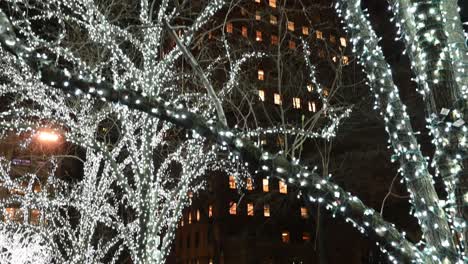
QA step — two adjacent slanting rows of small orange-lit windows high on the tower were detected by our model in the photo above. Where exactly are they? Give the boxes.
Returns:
[226,20,347,49]
